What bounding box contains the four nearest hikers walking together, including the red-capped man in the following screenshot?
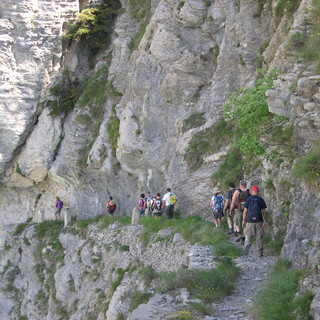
[210,181,268,257]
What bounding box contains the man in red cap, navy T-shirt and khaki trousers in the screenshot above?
[242,186,268,257]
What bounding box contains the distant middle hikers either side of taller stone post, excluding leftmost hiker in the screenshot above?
[106,188,177,219]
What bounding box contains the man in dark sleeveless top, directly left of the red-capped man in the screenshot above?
[230,180,250,244]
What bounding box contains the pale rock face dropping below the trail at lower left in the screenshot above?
[0,223,213,320]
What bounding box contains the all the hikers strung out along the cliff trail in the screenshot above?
[52,181,268,257]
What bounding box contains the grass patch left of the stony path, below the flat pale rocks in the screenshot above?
[155,258,239,302]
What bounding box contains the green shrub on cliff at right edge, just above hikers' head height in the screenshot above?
[293,142,320,186]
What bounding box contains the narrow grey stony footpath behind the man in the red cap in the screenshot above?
[210,236,277,320]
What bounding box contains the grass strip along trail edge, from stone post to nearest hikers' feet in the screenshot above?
[141,216,241,258]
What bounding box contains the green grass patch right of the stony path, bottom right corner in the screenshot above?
[254,259,312,320]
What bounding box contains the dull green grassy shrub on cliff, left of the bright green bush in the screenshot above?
[184,119,232,170]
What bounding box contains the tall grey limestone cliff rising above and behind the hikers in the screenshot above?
[0,0,320,318]
